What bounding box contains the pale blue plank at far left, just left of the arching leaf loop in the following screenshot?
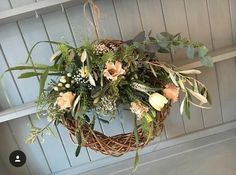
[0,23,38,102]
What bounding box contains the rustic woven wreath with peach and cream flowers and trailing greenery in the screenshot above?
[1,32,212,169]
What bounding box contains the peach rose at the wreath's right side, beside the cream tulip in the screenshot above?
[163,84,179,102]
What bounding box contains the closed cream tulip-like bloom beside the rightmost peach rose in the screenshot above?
[148,93,168,111]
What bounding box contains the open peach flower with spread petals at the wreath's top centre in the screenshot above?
[103,61,125,81]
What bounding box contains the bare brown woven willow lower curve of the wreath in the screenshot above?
[63,103,171,157]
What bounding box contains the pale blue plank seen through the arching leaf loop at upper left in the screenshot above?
[19,14,92,166]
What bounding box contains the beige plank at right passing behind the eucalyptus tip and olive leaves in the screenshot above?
[186,0,222,127]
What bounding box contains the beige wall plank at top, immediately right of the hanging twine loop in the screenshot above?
[114,0,143,40]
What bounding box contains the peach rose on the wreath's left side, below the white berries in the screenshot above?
[57,92,75,110]
